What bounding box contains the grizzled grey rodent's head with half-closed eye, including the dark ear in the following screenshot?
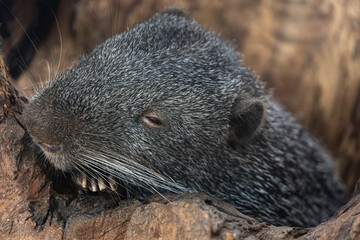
[24,10,265,195]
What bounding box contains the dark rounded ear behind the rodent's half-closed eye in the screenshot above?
[230,99,266,142]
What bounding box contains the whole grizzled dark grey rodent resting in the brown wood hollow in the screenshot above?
[24,9,346,227]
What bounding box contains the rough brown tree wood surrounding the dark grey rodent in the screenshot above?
[0,0,360,240]
